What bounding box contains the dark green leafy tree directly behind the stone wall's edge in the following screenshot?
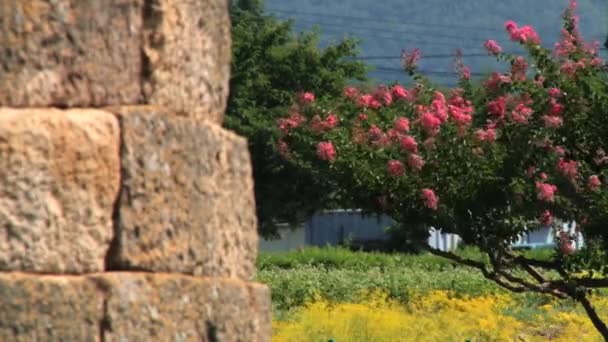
[225,0,366,235]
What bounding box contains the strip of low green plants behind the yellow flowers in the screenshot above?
[256,248,552,315]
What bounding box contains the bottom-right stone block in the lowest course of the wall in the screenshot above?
[99,273,271,342]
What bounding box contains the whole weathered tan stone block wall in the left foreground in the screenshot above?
[0,0,270,341]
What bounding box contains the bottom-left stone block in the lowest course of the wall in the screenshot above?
[0,273,104,342]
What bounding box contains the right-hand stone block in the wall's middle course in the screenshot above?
[108,106,257,279]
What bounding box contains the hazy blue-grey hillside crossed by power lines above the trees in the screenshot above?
[266,0,608,85]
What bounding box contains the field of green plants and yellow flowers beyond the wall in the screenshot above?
[256,247,608,342]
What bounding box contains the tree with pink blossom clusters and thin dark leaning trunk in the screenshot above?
[278,1,608,339]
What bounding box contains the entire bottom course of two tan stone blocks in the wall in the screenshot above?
[0,272,271,342]
